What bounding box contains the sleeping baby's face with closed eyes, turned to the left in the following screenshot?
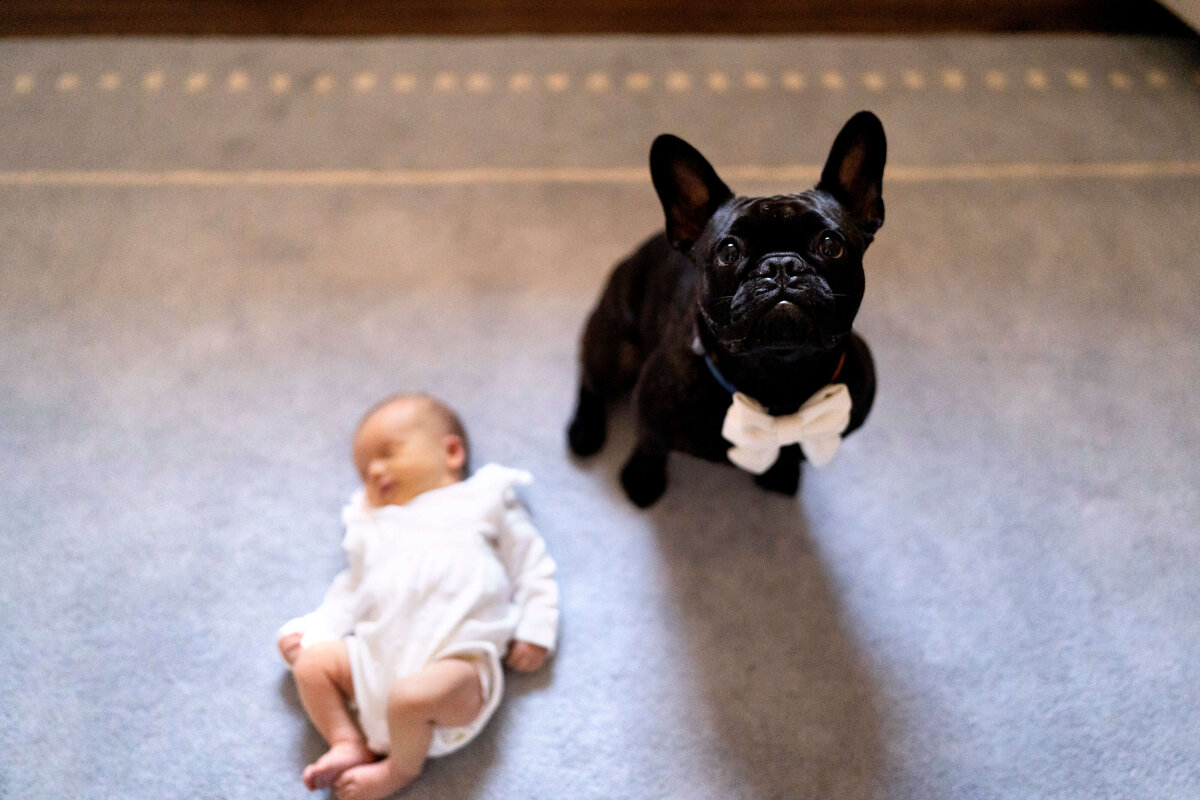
[354,399,464,506]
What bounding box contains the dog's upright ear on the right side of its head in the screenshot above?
[817,112,888,242]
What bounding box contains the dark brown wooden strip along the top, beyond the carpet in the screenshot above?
[0,0,1192,36]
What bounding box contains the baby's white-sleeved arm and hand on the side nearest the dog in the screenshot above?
[497,491,558,670]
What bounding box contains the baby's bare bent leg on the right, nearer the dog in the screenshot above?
[334,658,484,800]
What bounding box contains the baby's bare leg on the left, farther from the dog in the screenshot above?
[292,642,376,789]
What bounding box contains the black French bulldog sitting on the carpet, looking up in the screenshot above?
[568,112,887,507]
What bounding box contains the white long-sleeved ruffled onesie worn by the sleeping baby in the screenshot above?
[278,464,558,756]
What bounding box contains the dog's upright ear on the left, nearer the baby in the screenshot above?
[650,133,733,251]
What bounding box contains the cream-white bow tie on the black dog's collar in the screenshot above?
[721,384,851,475]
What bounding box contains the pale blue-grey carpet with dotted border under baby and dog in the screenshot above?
[0,36,1200,800]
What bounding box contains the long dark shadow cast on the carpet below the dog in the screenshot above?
[649,456,883,800]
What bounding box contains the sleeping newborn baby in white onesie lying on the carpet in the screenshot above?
[278,395,558,800]
